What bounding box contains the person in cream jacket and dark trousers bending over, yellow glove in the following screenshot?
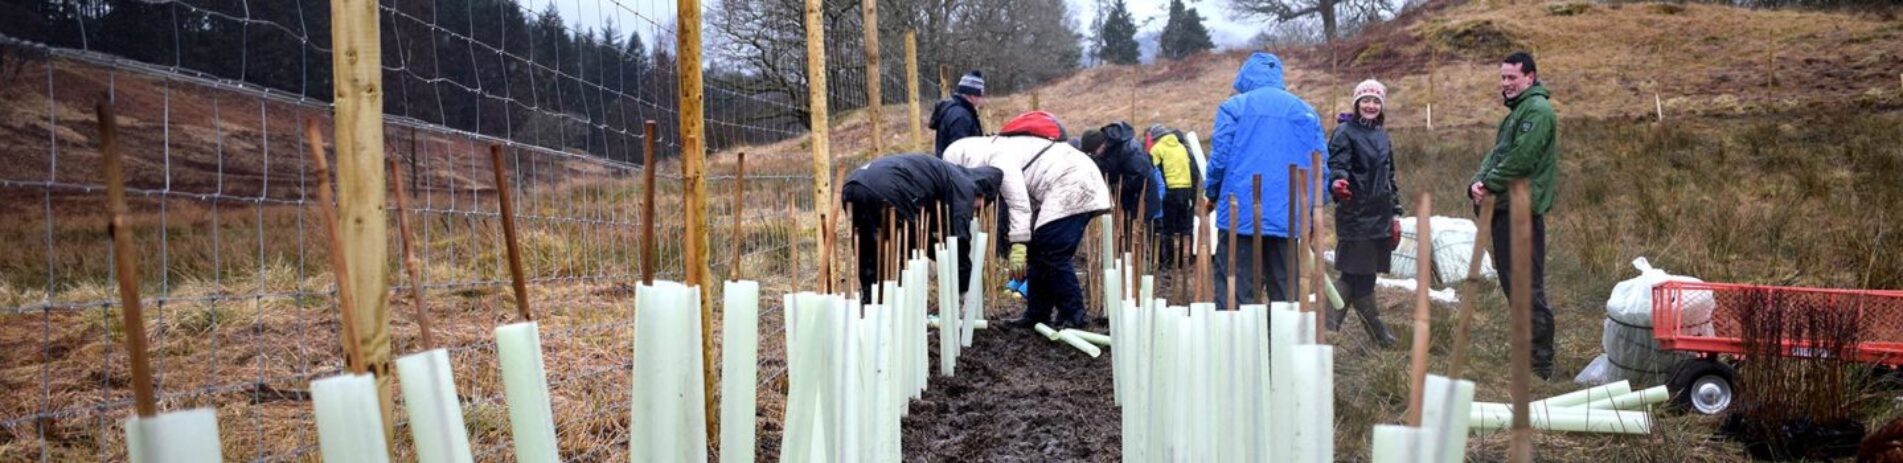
[944,111,1111,328]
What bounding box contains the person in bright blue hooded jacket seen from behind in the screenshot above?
[1203,51,1328,309]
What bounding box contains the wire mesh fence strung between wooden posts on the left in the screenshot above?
[0,0,924,461]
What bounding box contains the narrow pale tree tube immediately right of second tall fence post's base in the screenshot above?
[719,280,761,463]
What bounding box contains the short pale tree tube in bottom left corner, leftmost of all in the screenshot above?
[126,408,221,463]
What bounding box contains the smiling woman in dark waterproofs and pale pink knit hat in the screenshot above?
[1328,78,1401,347]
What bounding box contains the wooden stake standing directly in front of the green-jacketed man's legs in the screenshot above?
[1507,179,1534,463]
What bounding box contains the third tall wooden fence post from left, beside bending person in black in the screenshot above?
[807,0,834,290]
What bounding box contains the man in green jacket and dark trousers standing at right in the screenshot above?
[1467,51,1559,379]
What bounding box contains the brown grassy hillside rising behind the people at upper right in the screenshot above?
[716,0,1903,171]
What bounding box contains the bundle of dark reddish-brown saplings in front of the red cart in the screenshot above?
[1717,290,1874,459]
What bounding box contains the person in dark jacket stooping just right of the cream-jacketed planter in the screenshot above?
[1079,120,1163,242]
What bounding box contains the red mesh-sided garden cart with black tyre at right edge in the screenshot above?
[1652,282,1903,415]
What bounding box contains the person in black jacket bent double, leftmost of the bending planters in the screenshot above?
[839,154,1003,301]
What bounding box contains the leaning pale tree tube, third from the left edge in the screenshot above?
[396,349,476,463]
